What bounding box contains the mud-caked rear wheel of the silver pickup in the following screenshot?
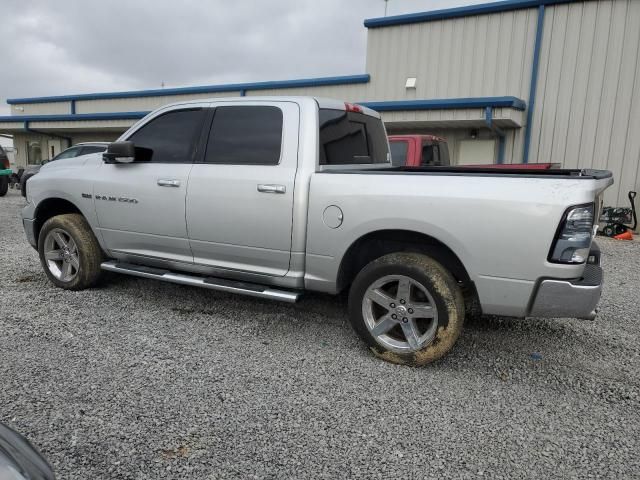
[349,253,465,366]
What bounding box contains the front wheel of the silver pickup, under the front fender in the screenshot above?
[38,213,103,290]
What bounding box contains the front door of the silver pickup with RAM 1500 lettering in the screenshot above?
[93,107,206,263]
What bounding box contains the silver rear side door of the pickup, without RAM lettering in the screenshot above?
[187,101,299,276]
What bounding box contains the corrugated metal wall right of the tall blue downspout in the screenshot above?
[530,0,640,205]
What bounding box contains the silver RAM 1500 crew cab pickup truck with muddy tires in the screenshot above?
[22,97,613,365]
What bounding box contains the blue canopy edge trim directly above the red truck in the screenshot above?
[358,97,527,112]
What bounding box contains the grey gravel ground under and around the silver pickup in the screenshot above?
[0,191,640,479]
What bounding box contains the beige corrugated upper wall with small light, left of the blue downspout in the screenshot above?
[367,9,537,100]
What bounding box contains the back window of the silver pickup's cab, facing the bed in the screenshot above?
[319,108,388,165]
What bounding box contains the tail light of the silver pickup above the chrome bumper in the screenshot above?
[549,203,595,263]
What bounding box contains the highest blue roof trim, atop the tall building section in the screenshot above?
[364,0,584,28]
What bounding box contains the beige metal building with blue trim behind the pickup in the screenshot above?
[0,0,640,205]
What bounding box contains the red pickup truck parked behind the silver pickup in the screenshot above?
[389,135,560,170]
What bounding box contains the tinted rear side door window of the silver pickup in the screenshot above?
[205,105,283,165]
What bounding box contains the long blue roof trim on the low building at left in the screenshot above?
[7,73,371,105]
